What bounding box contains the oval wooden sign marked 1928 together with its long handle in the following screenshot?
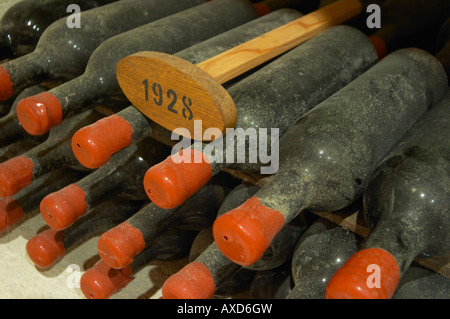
[117,0,362,141]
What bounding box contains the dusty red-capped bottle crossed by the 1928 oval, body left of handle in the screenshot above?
[72,9,301,167]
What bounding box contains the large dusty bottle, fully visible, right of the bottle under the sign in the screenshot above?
[213,49,447,265]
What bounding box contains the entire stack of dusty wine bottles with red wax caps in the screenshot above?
[0,0,450,299]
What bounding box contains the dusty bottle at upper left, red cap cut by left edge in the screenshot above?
[0,0,204,103]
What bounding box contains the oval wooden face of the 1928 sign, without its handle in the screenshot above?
[117,51,237,139]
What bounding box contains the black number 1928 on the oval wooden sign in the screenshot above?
[142,79,194,120]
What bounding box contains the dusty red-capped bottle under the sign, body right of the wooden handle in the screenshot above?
[144,26,377,208]
